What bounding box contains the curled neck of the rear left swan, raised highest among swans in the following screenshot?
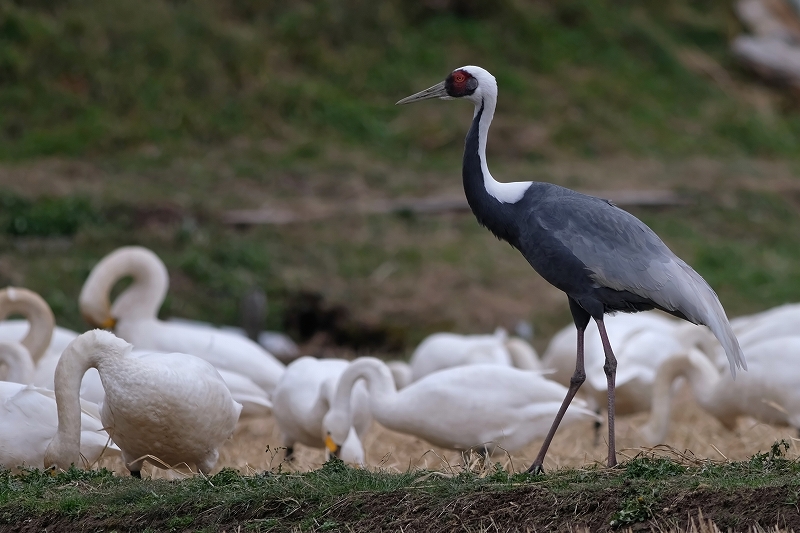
[80,249,169,320]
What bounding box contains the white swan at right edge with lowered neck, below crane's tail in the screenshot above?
[640,336,800,444]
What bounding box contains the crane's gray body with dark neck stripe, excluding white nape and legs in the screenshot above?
[463,102,744,373]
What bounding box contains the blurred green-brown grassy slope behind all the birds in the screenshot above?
[0,0,800,358]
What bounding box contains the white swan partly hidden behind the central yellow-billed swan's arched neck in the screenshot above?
[273,356,372,464]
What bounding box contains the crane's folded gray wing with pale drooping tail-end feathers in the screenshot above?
[537,193,747,375]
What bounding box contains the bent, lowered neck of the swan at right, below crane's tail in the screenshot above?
[648,350,720,442]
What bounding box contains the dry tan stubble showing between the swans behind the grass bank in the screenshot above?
[97,382,800,477]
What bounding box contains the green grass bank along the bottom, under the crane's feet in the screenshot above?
[0,448,800,531]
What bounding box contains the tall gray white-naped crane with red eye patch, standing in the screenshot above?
[397,66,747,473]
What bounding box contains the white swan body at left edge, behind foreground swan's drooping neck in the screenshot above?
[0,381,119,471]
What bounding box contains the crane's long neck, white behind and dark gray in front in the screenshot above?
[462,97,531,244]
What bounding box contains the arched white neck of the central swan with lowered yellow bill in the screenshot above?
[331,357,397,423]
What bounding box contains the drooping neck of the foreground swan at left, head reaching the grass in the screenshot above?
[44,337,102,469]
